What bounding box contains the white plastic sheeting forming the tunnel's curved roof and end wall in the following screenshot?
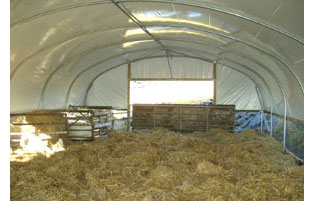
[11,0,304,120]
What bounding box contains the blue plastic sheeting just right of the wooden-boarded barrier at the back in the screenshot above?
[234,112,280,133]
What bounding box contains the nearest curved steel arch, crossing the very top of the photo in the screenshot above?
[10,0,304,44]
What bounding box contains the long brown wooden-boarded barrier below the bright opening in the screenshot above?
[132,104,235,131]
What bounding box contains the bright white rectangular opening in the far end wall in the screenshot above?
[130,80,214,105]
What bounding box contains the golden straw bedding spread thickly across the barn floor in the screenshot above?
[11,130,304,201]
